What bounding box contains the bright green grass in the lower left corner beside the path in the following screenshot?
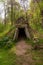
[0,49,16,65]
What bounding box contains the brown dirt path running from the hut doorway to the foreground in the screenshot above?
[12,40,34,65]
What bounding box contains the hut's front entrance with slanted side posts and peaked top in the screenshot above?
[14,17,30,39]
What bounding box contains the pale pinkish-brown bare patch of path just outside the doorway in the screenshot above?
[16,40,31,56]
